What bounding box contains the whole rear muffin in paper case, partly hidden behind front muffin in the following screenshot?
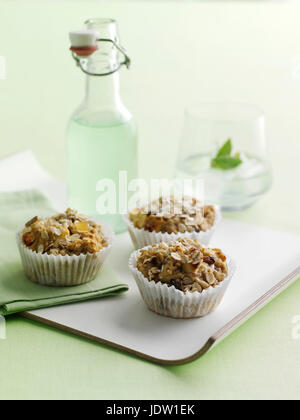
[124,197,221,249]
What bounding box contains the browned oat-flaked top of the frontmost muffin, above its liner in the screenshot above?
[136,239,228,293]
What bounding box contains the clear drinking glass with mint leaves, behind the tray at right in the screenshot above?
[176,103,272,211]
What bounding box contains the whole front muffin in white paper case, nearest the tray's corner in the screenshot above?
[129,238,235,318]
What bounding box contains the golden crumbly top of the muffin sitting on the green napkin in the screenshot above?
[22,209,108,256]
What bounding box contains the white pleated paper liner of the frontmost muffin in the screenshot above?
[129,247,236,318]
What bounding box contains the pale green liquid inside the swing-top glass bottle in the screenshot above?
[67,118,137,233]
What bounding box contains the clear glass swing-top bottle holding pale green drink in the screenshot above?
[67,19,137,233]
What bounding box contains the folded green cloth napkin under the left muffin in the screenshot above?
[0,191,128,315]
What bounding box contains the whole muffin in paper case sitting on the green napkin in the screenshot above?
[17,209,113,286]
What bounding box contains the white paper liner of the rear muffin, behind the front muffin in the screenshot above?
[123,206,222,249]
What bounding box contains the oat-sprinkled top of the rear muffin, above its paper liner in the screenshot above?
[129,197,216,234]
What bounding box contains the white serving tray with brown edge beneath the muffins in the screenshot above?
[24,220,300,365]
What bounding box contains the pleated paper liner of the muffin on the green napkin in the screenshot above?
[17,220,114,287]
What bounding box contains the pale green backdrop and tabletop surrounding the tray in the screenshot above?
[0,1,300,399]
